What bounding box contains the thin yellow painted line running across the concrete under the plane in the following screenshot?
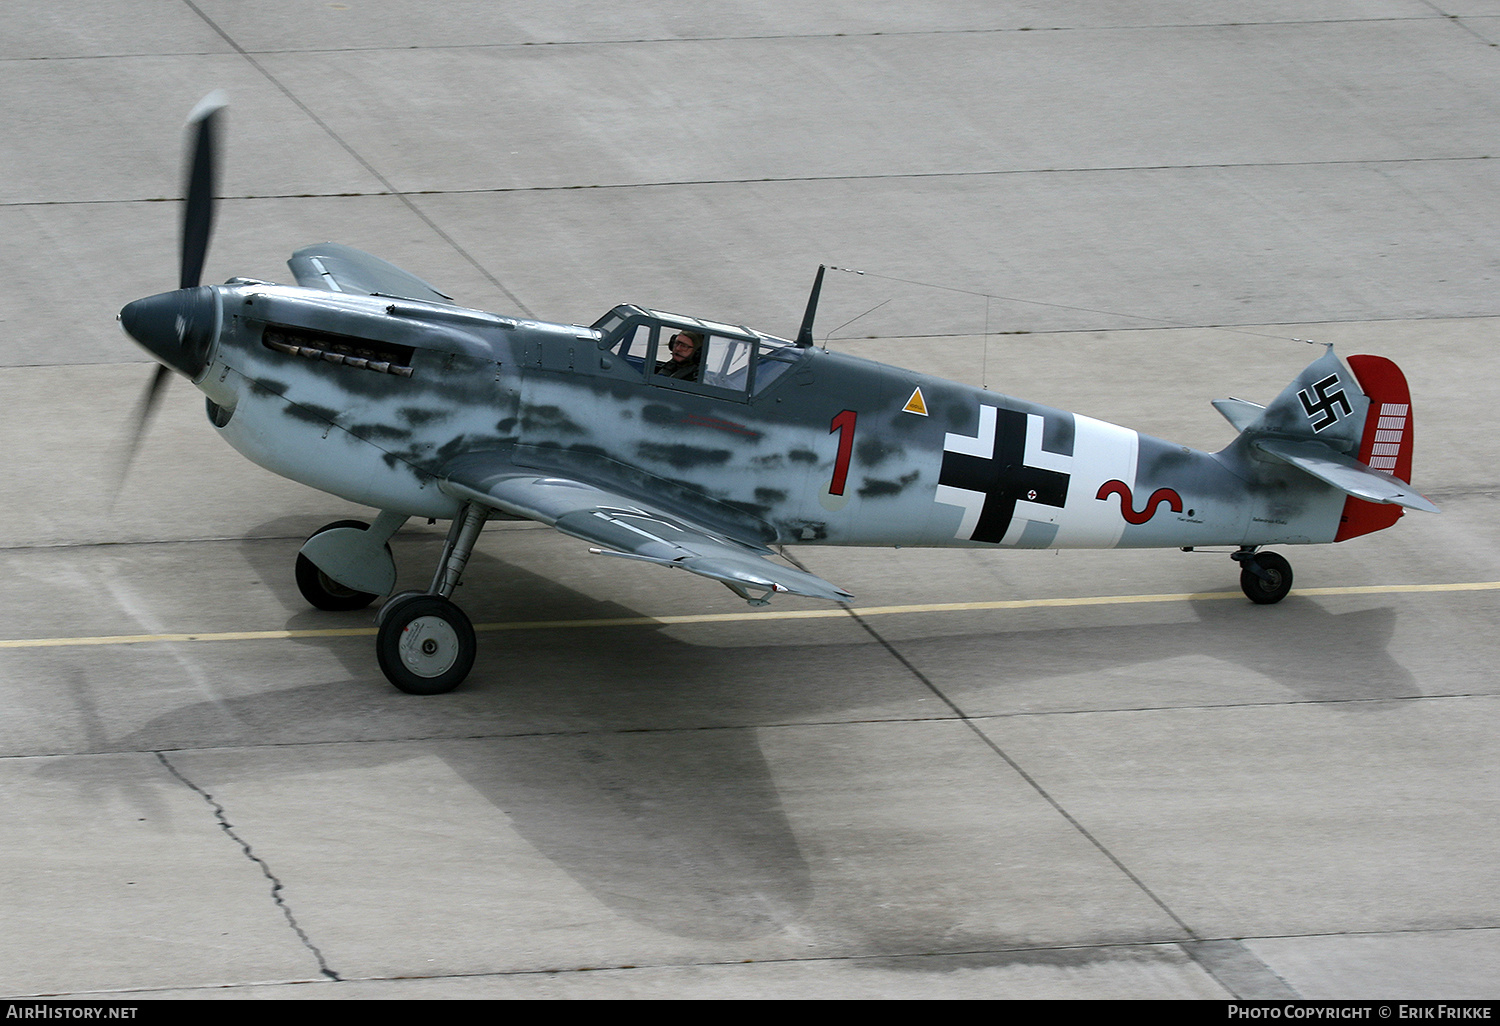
[0,581,1500,648]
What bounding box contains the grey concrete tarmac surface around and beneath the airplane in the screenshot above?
[0,0,1500,999]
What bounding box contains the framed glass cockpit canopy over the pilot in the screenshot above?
[593,303,806,402]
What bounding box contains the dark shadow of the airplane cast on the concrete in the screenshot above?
[43,525,1416,939]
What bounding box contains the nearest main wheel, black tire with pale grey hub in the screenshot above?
[375,596,479,695]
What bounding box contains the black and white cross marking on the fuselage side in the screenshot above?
[936,405,1070,545]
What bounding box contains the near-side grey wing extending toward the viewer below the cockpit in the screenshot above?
[440,453,854,605]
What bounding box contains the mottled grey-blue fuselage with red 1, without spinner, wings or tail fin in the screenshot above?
[172,282,1344,548]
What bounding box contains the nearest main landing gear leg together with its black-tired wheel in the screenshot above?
[375,503,489,695]
